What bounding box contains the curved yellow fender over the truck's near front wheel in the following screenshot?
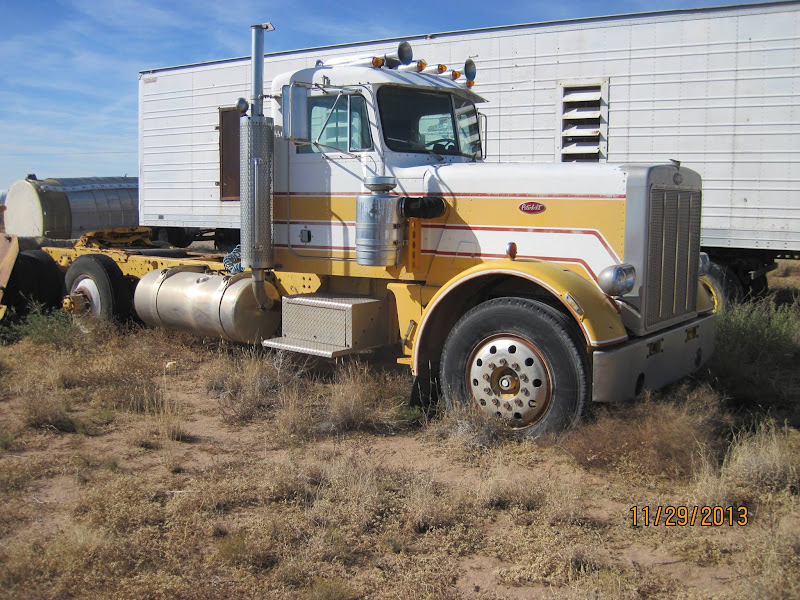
[413,259,628,373]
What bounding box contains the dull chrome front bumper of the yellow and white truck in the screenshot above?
[592,314,715,402]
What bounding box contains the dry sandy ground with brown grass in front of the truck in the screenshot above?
[0,264,800,600]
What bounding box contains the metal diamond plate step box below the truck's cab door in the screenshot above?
[262,294,392,358]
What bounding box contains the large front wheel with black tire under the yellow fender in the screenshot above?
[440,298,589,437]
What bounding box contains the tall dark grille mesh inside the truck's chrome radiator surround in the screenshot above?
[645,187,702,329]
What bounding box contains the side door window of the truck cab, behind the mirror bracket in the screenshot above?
[297,94,372,154]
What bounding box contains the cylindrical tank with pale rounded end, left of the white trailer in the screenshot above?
[4,177,139,239]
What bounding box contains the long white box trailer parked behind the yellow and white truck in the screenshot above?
[139,1,800,295]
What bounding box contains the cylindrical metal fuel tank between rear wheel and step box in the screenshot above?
[133,267,280,344]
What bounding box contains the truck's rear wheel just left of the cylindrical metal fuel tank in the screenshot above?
[65,254,131,320]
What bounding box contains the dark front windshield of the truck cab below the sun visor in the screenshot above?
[378,86,481,158]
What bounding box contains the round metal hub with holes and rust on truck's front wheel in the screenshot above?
[466,334,552,428]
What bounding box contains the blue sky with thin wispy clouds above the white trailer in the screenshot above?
[0,0,764,190]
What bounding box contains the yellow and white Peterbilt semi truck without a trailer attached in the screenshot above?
[0,23,714,436]
